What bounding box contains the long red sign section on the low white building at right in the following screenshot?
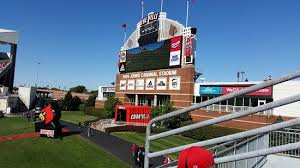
[222,86,272,96]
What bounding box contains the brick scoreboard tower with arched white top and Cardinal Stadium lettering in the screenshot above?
[116,12,197,108]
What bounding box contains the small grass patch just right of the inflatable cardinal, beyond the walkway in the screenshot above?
[61,111,97,124]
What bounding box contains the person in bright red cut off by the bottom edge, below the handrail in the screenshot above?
[177,146,216,168]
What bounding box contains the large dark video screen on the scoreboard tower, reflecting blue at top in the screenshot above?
[123,40,171,72]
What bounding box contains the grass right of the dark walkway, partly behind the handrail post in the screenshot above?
[112,132,196,159]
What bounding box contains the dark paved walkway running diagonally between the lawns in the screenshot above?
[61,121,164,167]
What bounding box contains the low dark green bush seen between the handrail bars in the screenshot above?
[181,121,242,141]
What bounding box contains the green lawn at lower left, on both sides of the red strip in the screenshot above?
[0,118,129,168]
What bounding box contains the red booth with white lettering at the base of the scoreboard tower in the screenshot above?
[115,105,151,124]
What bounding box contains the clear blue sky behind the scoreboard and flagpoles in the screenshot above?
[0,0,300,89]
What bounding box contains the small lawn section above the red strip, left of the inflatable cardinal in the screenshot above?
[0,117,34,136]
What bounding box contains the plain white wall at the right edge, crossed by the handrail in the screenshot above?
[273,81,300,117]
